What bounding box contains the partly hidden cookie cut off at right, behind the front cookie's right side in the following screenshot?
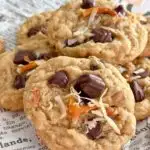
[120,57,150,120]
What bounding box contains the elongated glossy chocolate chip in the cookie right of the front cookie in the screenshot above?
[130,81,145,102]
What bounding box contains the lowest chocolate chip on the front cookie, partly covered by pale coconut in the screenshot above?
[86,121,102,140]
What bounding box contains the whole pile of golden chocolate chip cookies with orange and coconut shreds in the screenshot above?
[0,0,150,150]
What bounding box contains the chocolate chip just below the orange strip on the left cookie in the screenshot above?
[14,75,27,89]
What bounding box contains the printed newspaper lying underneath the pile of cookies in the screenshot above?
[0,0,150,150]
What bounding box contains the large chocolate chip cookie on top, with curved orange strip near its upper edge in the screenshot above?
[48,0,147,64]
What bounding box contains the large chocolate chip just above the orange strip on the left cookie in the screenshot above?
[14,51,36,65]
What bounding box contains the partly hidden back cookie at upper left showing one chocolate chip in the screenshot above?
[17,11,52,51]
